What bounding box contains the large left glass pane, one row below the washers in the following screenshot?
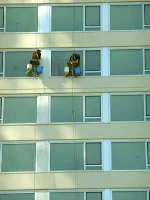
[4,97,37,123]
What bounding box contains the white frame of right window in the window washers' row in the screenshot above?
[109,46,150,76]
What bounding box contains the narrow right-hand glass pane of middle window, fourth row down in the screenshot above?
[86,142,101,165]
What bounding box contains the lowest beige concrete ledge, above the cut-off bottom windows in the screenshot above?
[0,171,150,191]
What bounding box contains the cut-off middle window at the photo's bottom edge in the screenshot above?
[50,192,102,200]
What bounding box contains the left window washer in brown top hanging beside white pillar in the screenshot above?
[26,50,41,77]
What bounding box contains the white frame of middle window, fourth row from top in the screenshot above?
[48,140,104,172]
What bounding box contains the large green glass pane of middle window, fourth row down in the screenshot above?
[50,143,84,171]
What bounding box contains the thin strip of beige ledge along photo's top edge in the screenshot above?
[0,0,149,5]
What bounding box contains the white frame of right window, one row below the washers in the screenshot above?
[109,92,150,123]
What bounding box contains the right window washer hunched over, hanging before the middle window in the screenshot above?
[64,54,80,77]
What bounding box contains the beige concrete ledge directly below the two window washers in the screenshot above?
[0,76,150,95]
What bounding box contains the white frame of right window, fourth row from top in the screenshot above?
[110,139,150,171]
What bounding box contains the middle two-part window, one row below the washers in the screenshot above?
[51,96,101,123]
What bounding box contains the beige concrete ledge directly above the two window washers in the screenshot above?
[0,30,150,49]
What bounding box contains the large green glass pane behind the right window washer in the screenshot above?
[51,51,83,76]
